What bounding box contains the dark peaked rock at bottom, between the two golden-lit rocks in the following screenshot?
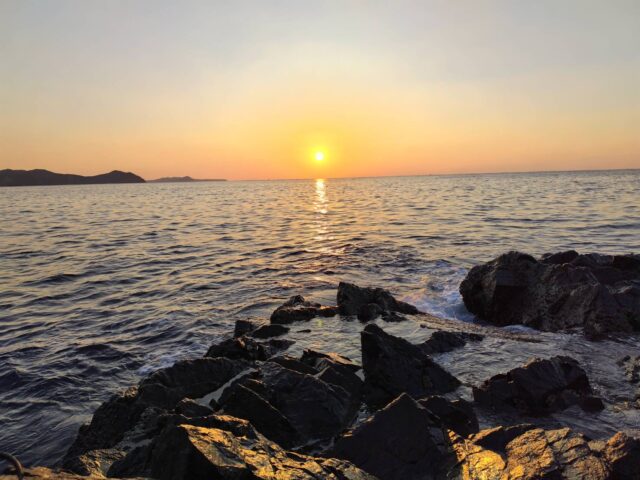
[331,394,448,480]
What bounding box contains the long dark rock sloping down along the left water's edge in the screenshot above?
[62,358,249,473]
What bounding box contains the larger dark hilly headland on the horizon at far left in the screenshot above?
[0,169,144,187]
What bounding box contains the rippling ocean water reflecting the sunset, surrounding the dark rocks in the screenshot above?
[0,171,640,465]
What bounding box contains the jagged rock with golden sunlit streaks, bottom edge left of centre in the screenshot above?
[134,417,375,480]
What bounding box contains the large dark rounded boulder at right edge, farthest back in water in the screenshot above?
[460,251,640,338]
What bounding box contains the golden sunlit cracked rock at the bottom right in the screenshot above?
[450,428,618,480]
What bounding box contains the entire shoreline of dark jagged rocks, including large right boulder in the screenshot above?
[5,252,640,480]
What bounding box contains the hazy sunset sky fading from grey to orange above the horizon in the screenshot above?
[0,0,640,179]
